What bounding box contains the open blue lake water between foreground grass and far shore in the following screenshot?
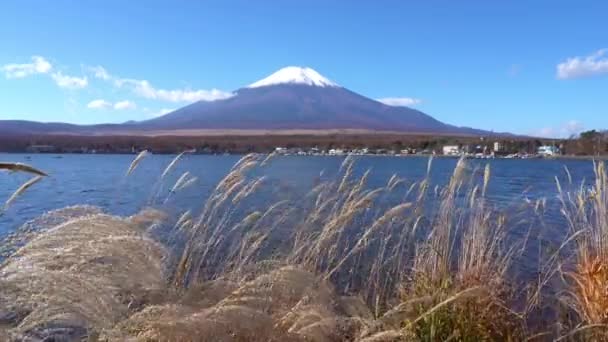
[0,154,593,252]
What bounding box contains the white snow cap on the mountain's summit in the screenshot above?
[247,66,339,88]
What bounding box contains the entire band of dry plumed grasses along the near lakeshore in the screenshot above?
[0,152,608,342]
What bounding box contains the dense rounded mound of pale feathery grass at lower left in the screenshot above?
[0,211,165,340]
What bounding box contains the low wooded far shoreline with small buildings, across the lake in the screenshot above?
[0,131,608,158]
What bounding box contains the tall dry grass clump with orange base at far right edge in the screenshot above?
[557,162,608,340]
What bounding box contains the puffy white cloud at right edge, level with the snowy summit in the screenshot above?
[557,49,608,80]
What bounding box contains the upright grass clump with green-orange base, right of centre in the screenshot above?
[401,159,528,341]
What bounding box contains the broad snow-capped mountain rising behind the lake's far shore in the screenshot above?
[0,66,489,135]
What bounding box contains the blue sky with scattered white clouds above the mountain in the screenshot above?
[0,0,608,136]
